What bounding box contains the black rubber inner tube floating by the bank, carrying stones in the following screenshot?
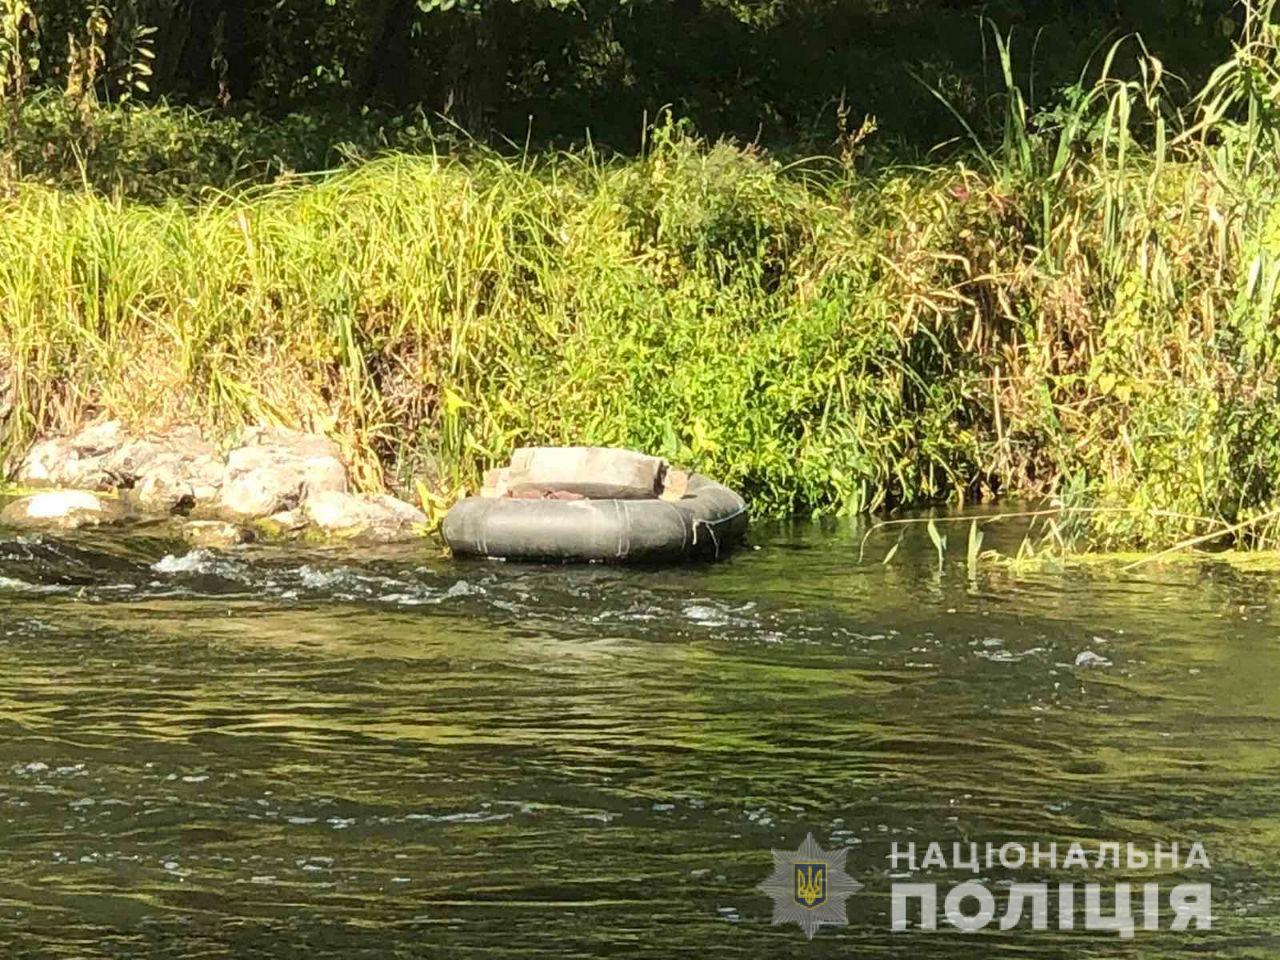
[443,474,746,563]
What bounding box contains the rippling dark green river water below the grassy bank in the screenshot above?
[0,524,1280,960]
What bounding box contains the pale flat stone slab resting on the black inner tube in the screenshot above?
[507,447,667,499]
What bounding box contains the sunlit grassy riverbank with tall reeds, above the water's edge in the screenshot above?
[0,12,1280,548]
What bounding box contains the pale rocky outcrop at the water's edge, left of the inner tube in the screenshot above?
[4,420,426,545]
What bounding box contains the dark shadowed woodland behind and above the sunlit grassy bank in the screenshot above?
[9,0,1238,151]
